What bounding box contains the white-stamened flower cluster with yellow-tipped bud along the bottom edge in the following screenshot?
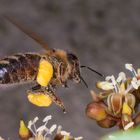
[19,115,83,140]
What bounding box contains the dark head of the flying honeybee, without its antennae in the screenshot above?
[67,53,81,83]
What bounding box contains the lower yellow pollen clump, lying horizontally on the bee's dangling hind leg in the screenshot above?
[28,92,52,107]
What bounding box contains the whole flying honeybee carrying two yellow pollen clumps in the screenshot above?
[0,16,102,112]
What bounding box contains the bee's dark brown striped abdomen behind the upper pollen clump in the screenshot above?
[0,53,41,84]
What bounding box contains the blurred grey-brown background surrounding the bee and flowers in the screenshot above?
[0,0,140,140]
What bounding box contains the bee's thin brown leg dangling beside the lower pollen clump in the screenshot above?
[45,85,66,113]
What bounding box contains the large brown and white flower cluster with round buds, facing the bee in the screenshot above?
[86,64,140,130]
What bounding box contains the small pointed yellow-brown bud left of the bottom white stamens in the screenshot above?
[19,120,30,137]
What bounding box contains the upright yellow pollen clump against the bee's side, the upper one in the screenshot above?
[37,60,53,87]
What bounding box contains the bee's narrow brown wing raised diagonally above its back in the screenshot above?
[4,15,50,50]
